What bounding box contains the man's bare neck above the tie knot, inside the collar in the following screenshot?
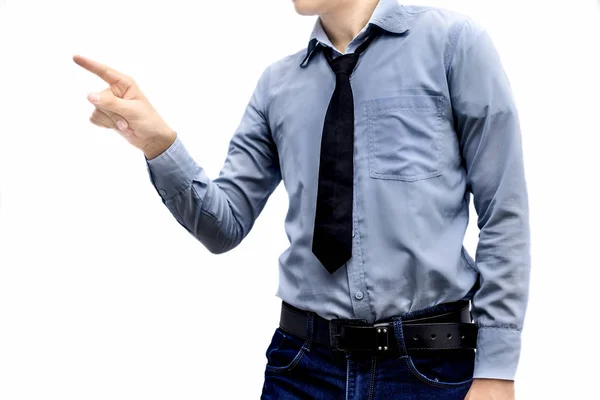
[319,0,379,54]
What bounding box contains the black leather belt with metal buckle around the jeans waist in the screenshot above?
[279,300,477,352]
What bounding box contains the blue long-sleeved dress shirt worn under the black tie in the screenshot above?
[146,0,530,379]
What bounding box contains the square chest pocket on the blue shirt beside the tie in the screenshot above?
[366,94,443,181]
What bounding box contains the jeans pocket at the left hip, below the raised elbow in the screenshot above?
[266,328,308,373]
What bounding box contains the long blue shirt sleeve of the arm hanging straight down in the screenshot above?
[448,20,530,380]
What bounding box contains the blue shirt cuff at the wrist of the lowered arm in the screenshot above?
[473,327,521,380]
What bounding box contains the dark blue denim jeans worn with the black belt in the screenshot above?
[261,303,475,400]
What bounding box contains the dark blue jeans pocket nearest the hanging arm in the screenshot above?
[404,349,475,387]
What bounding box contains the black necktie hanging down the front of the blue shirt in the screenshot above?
[312,29,379,274]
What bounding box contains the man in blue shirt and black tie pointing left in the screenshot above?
[74,0,530,400]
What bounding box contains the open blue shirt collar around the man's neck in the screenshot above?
[300,0,408,67]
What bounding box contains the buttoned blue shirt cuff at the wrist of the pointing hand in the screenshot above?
[144,136,201,201]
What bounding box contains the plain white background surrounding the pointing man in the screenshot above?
[0,0,600,400]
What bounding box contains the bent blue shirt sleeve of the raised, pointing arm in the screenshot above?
[146,68,281,254]
